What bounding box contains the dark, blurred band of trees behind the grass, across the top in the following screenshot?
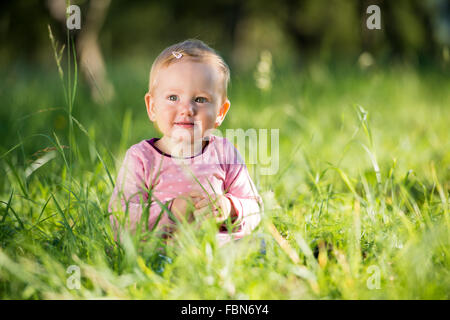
[0,0,450,73]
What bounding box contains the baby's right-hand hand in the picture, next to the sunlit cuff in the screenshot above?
[189,191,234,223]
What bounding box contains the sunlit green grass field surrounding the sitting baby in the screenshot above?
[0,43,450,299]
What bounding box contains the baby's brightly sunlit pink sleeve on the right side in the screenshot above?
[224,145,263,237]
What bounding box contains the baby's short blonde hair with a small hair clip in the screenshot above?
[148,39,230,99]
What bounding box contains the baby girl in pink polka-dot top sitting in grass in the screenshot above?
[109,40,263,244]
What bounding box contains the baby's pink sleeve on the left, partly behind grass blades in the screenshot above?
[108,148,173,238]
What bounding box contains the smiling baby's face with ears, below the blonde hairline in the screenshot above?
[145,57,230,143]
